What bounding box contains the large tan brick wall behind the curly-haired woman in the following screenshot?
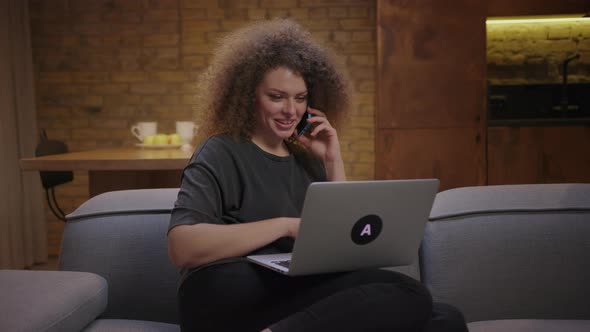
[29,0,376,255]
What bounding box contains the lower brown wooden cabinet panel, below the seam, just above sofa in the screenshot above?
[376,128,486,190]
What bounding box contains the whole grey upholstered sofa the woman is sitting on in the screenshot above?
[0,184,590,332]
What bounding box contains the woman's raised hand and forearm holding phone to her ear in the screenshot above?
[296,107,346,181]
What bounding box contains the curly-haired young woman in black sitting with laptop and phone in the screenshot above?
[168,20,467,332]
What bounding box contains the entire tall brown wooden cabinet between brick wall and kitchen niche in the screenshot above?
[375,0,487,190]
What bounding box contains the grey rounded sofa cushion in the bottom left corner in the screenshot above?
[0,270,108,331]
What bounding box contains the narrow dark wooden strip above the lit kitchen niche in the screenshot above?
[487,0,590,16]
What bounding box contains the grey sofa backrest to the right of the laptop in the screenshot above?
[420,184,590,321]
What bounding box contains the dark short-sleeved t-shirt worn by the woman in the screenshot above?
[168,135,326,274]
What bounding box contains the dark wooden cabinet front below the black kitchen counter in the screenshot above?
[488,126,590,185]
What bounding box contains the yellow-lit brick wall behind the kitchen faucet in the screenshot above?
[487,22,590,84]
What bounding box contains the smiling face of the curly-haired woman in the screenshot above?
[253,67,307,143]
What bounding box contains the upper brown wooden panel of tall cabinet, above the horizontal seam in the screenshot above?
[377,0,486,128]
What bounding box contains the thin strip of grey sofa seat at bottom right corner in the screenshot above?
[468,319,590,332]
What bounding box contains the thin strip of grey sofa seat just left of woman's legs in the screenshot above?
[84,319,180,332]
